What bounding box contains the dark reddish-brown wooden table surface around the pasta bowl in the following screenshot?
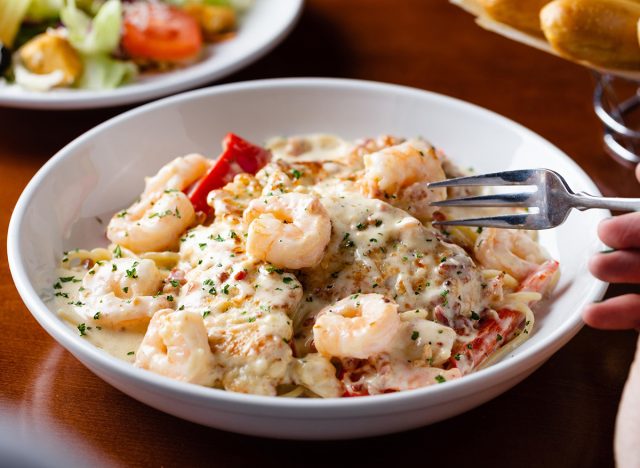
[0,0,640,467]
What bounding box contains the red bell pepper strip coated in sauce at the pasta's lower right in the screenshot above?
[449,309,524,374]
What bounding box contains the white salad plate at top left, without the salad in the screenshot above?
[0,0,304,109]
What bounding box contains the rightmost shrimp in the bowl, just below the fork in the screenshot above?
[474,228,549,281]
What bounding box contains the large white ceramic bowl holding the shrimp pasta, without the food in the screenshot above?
[8,79,608,439]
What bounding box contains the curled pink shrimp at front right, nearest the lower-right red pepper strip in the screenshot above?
[313,294,401,359]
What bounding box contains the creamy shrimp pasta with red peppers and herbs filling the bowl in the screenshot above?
[53,134,558,398]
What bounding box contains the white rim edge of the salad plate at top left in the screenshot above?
[0,0,304,110]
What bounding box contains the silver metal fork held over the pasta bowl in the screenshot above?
[429,169,640,229]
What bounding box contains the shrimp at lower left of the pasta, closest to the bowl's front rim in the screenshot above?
[134,309,217,386]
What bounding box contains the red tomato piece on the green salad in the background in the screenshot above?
[122,2,202,62]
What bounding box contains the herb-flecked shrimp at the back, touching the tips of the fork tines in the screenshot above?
[360,140,447,221]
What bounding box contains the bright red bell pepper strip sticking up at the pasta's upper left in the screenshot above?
[189,133,271,213]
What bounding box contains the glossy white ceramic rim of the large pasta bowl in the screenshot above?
[7,78,608,419]
